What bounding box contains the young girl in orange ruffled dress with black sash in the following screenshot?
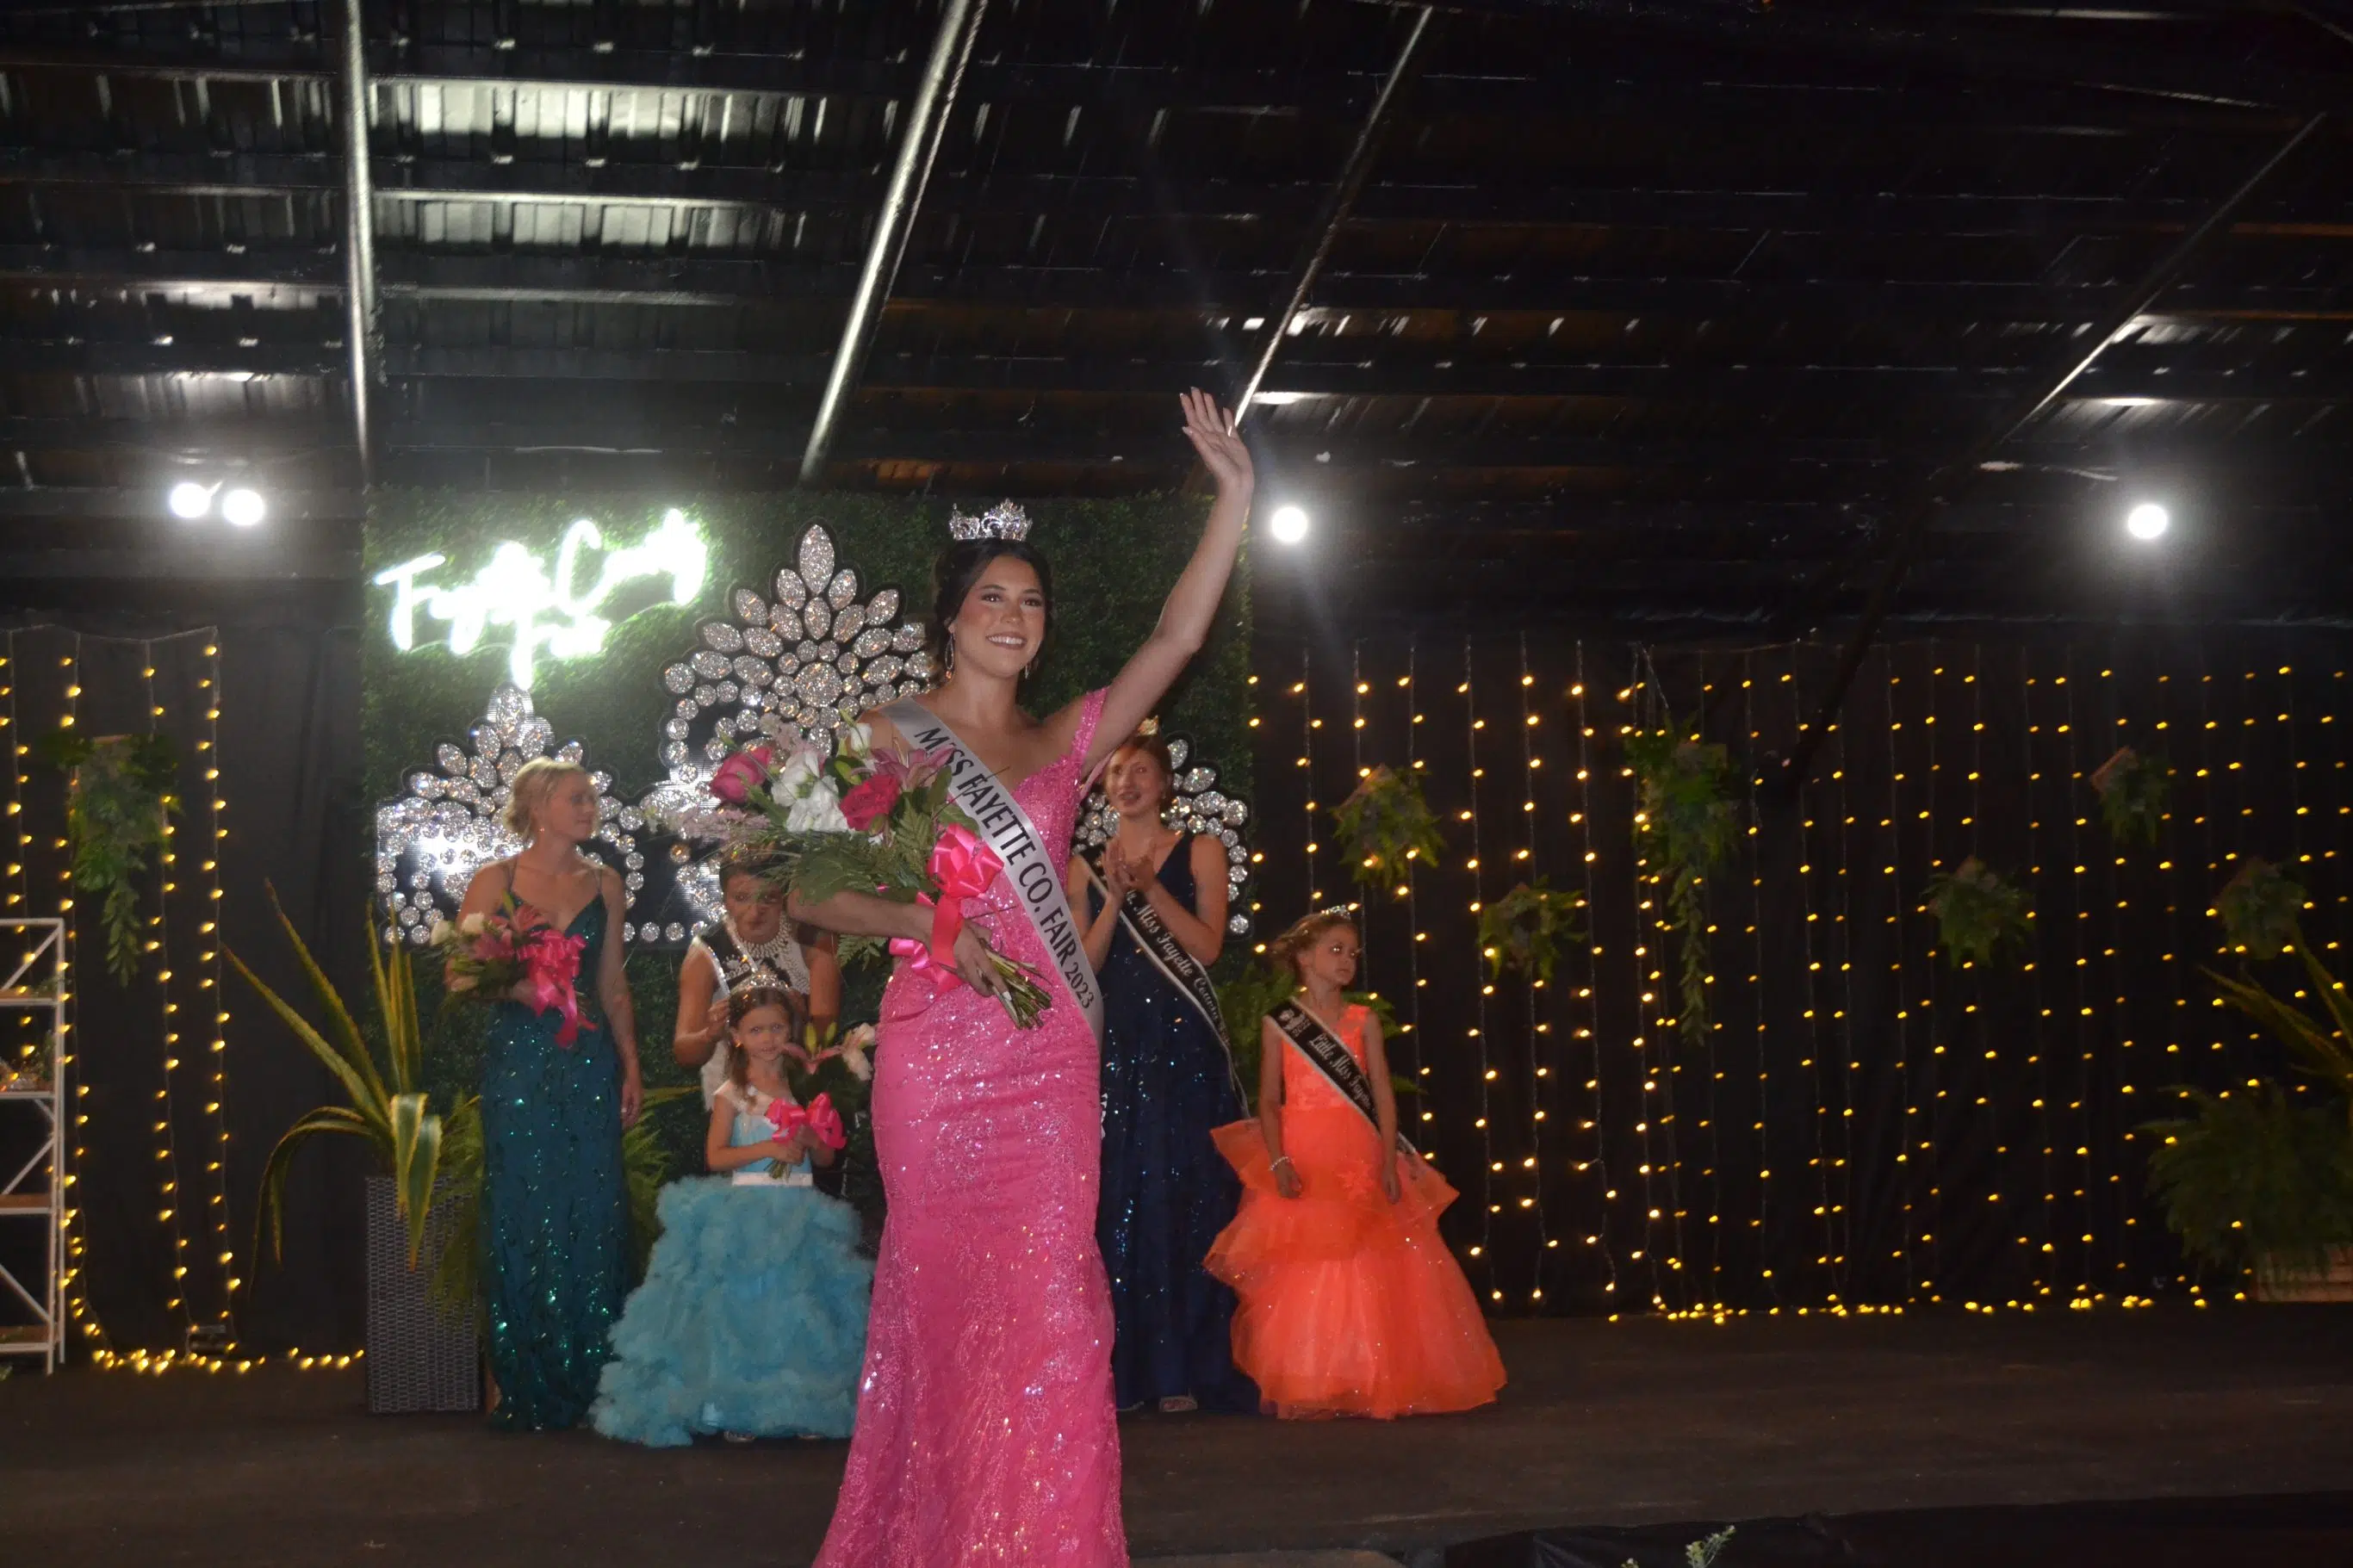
[1208,910,1504,1417]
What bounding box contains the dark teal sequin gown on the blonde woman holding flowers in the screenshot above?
[482,898,628,1432]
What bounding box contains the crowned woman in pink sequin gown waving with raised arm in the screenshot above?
[795,390,1251,1568]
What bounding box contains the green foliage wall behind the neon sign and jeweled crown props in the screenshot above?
[363,492,1251,1171]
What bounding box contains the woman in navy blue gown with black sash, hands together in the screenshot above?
[1071,734,1259,1410]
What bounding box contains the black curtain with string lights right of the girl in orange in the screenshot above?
[1254,630,2353,1314]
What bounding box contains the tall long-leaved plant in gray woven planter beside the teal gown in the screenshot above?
[228,889,482,1416]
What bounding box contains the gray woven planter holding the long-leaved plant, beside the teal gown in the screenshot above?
[367,1175,482,1416]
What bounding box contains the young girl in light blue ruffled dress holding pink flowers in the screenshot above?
[591,982,873,1448]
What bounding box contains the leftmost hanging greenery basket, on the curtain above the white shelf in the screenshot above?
[33,728,179,985]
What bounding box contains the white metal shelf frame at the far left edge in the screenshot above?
[0,917,71,1371]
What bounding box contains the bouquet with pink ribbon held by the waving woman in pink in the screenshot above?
[692,724,1052,1030]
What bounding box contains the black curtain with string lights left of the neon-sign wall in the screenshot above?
[0,595,369,1354]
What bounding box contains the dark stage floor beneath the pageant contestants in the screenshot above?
[0,1307,2353,1568]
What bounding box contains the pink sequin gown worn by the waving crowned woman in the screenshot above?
[816,691,1127,1568]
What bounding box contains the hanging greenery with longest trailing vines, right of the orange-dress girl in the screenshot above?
[1626,722,1741,1044]
